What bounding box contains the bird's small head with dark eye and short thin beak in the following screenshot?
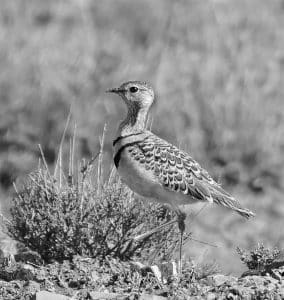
[107,81,154,110]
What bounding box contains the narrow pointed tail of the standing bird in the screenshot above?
[211,187,255,219]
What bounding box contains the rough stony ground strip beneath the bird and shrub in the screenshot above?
[0,252,284,300]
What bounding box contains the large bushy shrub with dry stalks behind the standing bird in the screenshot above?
[1,144,179,262]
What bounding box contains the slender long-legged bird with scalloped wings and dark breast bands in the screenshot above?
[107,81,254,272]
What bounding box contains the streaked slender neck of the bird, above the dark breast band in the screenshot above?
[118,104,149,136]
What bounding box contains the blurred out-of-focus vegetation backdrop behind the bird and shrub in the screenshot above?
[0,0,284,272]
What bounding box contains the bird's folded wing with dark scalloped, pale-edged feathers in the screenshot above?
[128,134,253,217]
